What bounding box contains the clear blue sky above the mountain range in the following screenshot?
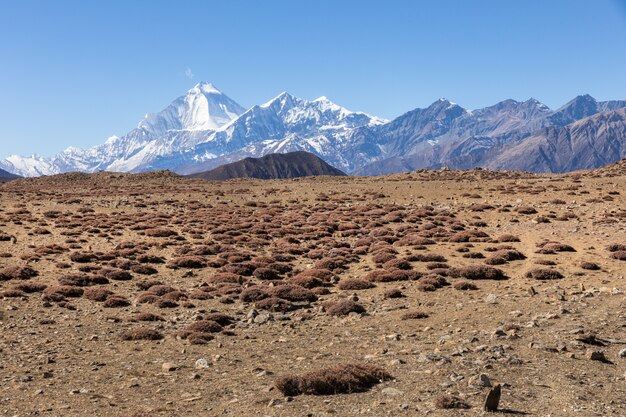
[0,0,626,156]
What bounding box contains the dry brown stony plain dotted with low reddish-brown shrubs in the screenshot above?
[0,161,626,417]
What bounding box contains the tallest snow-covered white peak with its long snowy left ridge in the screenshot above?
[0,82,245,176]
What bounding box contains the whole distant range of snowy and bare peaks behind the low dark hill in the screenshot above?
[0,82,626,176]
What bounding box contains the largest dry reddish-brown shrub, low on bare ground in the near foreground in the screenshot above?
[276,362,392,396]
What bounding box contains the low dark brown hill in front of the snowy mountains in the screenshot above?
[191,152,346,180]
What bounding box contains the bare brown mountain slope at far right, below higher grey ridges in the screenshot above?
[482,109,626,172]
